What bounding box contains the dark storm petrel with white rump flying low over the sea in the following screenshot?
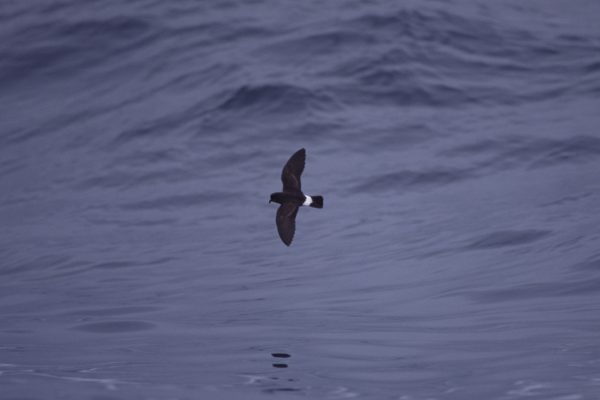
[269,149,323,246]
